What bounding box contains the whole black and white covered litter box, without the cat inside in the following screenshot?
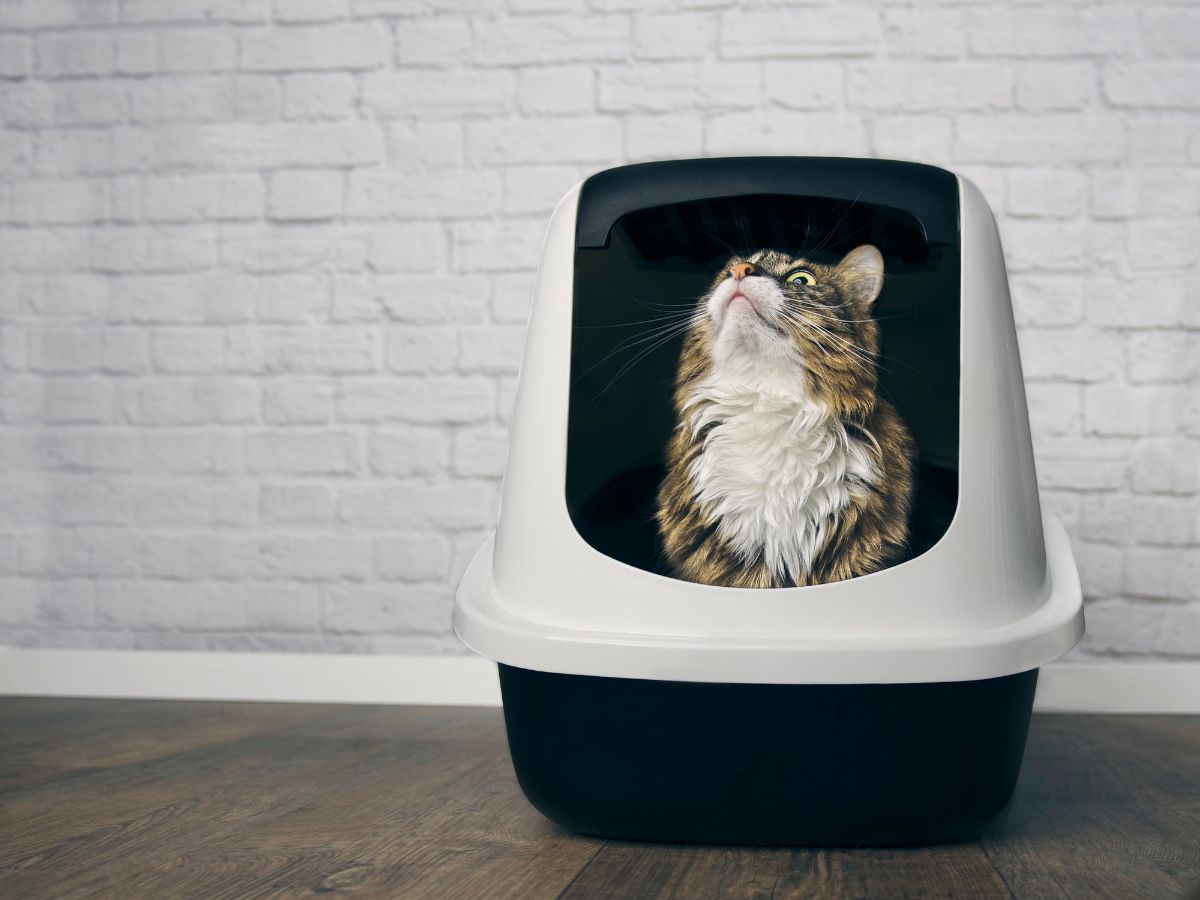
[454,157,1084,845]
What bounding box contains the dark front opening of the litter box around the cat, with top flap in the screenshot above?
[565,160,960,585]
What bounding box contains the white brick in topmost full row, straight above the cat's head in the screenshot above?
[718,7,881,59]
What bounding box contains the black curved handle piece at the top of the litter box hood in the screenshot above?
[575,156,959,247]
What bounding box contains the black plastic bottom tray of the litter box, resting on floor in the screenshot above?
[500,665,1037,846]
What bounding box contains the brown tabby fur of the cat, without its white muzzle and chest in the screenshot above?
[656,251,913,588]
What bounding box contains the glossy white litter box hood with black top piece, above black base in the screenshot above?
[454,157,1084,684]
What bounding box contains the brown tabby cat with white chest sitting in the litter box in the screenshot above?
[655,245,914,588]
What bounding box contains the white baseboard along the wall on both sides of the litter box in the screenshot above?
[0,647,1200,714]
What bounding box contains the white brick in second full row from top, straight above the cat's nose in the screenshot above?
[598,62,762,113]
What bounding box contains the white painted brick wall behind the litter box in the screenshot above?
[0,0,1200,658]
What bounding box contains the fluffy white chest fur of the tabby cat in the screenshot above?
[686,384,877,578]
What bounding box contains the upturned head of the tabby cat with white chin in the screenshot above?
[701,244,883,412]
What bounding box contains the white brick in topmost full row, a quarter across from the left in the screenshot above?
[239,23,391,72]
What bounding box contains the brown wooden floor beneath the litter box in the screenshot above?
[0,700,1200,900]
